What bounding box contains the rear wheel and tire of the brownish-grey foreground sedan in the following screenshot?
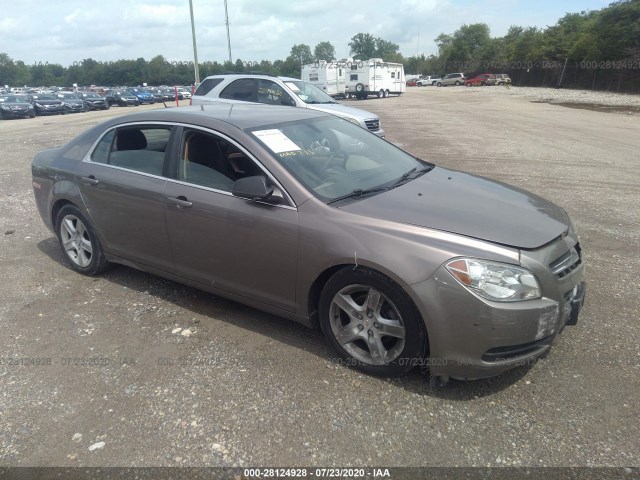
[56,205,109,276]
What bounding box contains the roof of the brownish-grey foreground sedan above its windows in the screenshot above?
[104,101,333,130]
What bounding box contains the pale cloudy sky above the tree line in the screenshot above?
[0,0,612,66]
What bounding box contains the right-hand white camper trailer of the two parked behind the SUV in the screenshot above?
[345,58,407,98]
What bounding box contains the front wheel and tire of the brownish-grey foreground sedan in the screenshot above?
[319,267,427,376]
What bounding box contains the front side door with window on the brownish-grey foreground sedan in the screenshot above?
[165,129,298,311]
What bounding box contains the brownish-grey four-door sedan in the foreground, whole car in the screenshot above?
[32,102,585,379]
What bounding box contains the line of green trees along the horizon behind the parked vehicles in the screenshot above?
[0,0,640,91]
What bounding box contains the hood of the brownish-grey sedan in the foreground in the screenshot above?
[341,167,569,249]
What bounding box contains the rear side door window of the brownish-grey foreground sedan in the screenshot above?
[91,126,171,176]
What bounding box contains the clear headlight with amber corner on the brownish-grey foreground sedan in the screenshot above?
[445,258,541,302]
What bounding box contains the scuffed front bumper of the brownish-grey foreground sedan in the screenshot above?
[409,244,586,380]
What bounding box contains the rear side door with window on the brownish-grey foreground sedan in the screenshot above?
[77,125,173,271]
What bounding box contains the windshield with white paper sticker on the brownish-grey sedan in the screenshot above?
[251,117,433,203]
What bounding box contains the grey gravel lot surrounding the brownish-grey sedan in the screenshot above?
[0,87,640,467]
